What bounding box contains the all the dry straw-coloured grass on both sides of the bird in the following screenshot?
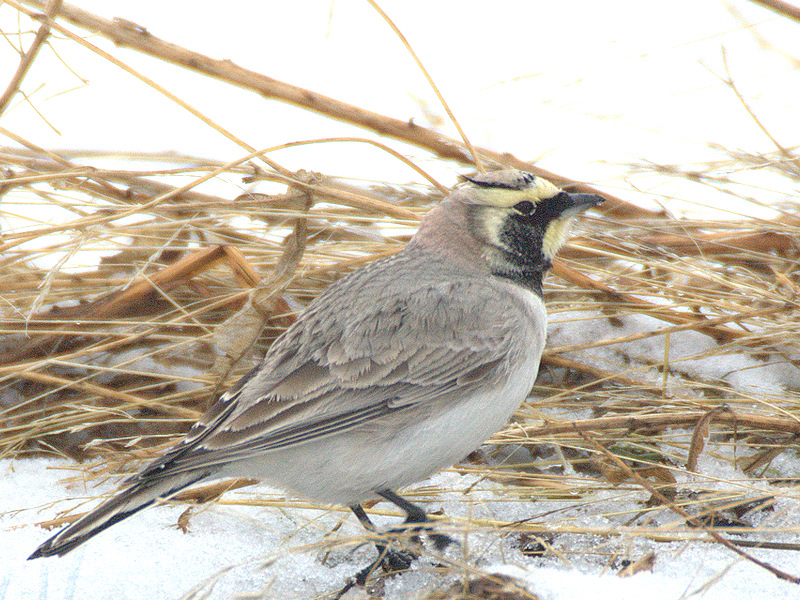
[0,0,800,592]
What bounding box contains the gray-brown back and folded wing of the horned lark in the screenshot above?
[138,272,543,473]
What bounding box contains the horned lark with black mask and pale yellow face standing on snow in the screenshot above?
[29,169,603,584]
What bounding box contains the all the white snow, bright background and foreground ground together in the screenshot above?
[0,0,800,600]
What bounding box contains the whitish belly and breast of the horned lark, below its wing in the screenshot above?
[226,286,545,505]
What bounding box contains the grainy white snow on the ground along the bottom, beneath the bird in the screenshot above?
[0,460,800,600]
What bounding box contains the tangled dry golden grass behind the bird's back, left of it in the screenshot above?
[0,150,432,456]
